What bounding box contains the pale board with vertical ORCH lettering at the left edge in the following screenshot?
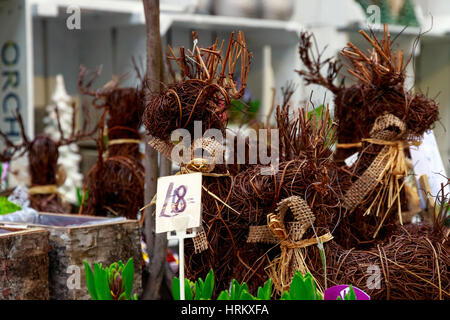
[0,0,34,145]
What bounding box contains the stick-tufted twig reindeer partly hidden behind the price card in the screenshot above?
[143,32,252,291]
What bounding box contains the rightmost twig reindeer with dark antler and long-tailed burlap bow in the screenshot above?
[298,25,438,247]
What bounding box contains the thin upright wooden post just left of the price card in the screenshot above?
[143,0,167,299]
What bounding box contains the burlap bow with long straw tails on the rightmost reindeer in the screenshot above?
[340,114,418,238]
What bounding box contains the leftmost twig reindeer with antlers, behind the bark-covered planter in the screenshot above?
[0,104,93,213]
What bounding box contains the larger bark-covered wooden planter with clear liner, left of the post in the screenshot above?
[0,213,142,300]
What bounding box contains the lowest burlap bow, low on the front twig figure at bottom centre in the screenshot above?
[247,196,333,293]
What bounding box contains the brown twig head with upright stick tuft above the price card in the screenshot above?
[143,32,251,141]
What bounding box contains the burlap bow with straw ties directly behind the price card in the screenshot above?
[141,137,234,253]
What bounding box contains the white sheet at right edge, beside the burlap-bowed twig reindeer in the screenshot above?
[410,131,450,208]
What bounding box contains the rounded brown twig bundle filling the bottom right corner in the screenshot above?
[307,224,450,300]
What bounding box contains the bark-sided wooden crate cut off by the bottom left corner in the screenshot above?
[0,227,49,300]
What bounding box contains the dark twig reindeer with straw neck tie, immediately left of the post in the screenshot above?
[79,67,144,219]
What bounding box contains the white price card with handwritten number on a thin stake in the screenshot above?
[155,173,202,233]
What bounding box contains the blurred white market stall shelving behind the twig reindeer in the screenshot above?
[0,0,450,201]
